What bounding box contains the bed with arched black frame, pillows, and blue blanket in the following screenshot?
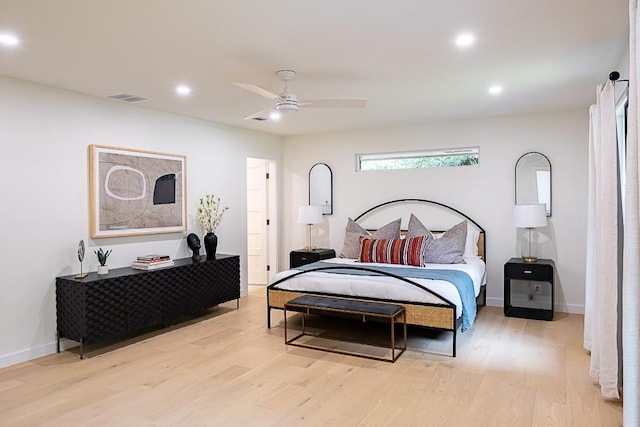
[267,199,486,357]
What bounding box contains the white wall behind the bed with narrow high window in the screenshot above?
[280,108,588,313]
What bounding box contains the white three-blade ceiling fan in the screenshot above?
[235,70,367,120]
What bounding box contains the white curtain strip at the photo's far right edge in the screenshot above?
[622,0,640,426]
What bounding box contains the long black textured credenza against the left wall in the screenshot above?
[56,254,240,358]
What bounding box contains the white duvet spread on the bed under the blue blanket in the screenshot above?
[271,257,486,318]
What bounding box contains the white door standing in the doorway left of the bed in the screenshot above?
[247,158,269,285]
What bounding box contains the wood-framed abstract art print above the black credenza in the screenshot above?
[89,145,187,238]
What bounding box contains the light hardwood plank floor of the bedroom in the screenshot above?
[0,288,622,427]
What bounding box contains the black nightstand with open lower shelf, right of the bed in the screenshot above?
[504,258,555,320]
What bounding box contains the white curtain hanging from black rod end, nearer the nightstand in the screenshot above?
[584,81,620,398]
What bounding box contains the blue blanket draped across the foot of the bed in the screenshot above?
[295,261,476,332]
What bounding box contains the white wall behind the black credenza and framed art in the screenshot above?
[0,78,282,366]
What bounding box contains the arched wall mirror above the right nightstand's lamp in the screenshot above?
[516,152,551,216]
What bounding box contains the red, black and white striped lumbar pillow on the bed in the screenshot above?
[358,236,431,267]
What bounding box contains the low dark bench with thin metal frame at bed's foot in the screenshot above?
[284,295,407,362]
